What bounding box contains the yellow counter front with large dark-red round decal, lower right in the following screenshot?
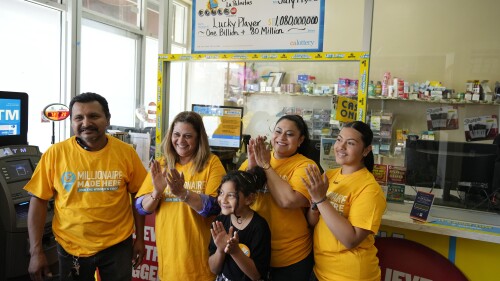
[376,196,500,281]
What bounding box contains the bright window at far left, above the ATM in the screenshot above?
[0,0,64,151]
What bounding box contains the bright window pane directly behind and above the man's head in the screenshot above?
[80,19,140,127]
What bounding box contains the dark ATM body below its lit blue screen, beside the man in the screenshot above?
[0,145,58,281]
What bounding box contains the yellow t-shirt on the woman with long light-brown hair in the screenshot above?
[137,155,226,281]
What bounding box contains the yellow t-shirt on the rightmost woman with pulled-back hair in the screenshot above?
[314,168,386,281]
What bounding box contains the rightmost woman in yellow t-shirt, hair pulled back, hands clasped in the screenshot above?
[303,121,386,281]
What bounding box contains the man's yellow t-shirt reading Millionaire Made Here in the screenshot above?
[24,136,147,257]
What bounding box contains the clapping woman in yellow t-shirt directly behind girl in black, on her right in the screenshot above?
[240,115,317,281]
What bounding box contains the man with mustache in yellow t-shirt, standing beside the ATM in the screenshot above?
[24,93,147,281]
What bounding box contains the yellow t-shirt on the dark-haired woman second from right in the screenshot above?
[240,153,316,267]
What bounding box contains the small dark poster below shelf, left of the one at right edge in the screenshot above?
[427,106,458,131]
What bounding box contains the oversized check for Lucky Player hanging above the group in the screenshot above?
[192,0,325,53]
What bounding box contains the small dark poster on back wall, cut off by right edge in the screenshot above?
[464,115,498,141]
